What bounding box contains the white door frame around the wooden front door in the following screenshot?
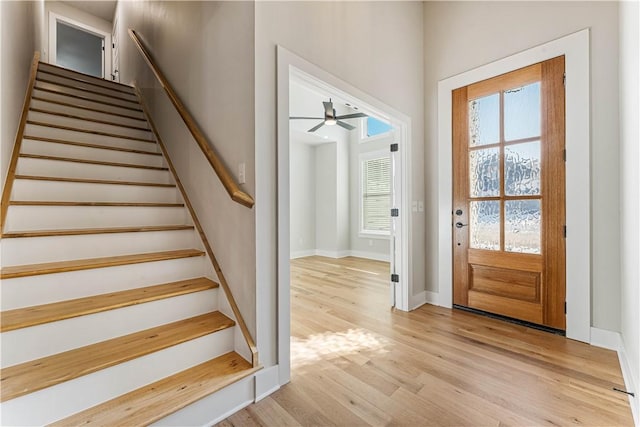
[437,28,591,342]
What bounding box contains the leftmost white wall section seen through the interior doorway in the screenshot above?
[289,137,316,257]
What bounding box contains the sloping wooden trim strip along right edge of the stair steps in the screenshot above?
[134,84,258,368]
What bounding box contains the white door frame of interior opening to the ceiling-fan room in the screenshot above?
[274,45,412,385]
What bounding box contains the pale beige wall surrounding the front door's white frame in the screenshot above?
[424,1,620,331]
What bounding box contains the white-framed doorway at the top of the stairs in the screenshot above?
[49,12,112,79]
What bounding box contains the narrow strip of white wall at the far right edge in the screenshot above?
[619,1,640,424]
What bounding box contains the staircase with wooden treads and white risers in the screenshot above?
[0,59,257,425]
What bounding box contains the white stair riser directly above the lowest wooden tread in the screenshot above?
[2,328,233,425]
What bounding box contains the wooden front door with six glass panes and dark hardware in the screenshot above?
[453,56,565,330]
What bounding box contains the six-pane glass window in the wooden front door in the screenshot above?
[468,82,542,255]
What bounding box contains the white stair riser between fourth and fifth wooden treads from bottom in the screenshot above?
[2,230,199,267]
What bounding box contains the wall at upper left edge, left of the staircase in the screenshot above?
[0,1,35,188]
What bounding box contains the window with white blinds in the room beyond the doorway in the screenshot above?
[361,155,391,234]
